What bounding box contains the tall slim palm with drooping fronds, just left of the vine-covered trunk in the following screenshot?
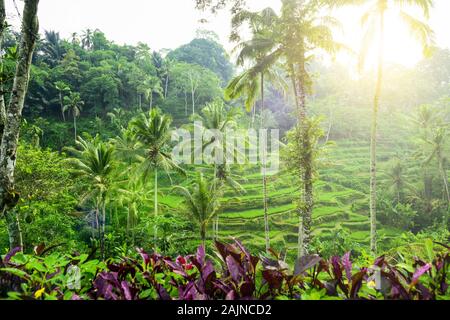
[225,8,281,251]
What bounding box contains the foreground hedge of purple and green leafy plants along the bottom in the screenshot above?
[0,240,450,300]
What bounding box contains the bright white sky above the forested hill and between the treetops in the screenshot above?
[6,0,450,65]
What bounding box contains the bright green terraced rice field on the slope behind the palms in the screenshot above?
[161,142,399,255]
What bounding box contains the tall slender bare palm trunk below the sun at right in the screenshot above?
[370,13,384,254]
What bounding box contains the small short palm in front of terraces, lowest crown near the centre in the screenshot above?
[174,173,220,246]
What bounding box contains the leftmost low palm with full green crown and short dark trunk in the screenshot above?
[67,136,115,255]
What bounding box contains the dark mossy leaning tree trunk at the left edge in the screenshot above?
[0,0,39,251]
